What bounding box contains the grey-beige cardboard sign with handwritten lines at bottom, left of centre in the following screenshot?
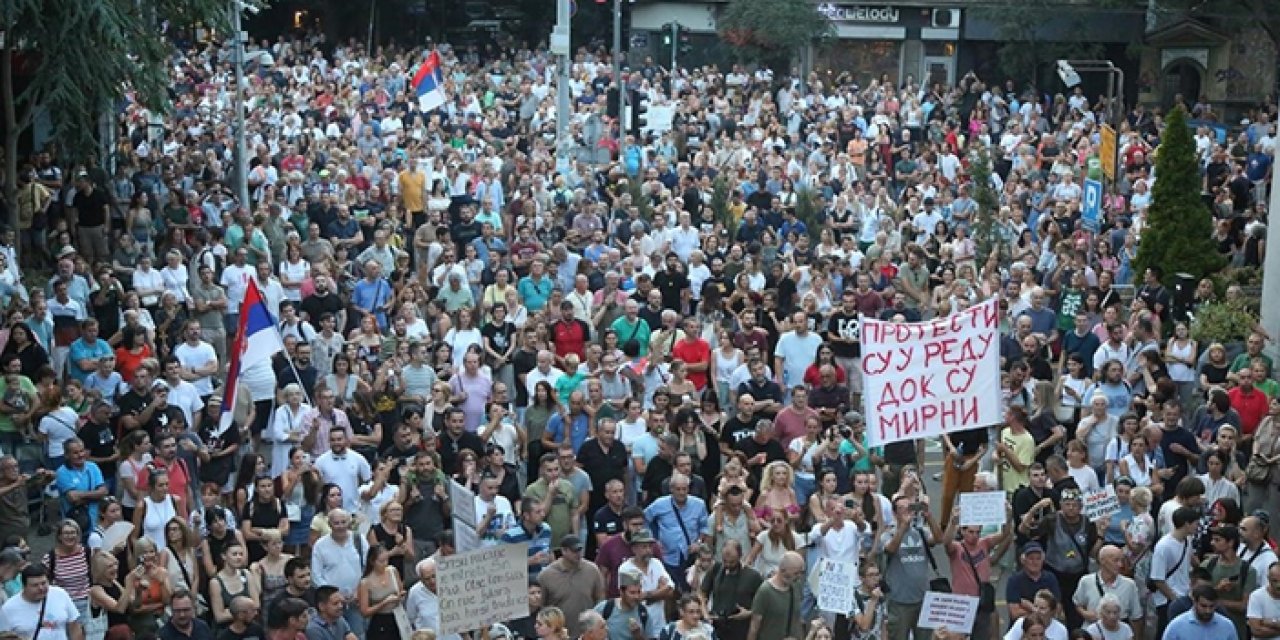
[436,543,529,635]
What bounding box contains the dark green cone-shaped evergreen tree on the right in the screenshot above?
[1134,108,1225,282]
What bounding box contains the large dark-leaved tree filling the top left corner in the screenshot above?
[0,0,235,235]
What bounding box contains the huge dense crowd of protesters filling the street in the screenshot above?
[0,18,1280,640]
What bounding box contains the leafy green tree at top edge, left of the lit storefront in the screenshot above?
[719,0,835,69]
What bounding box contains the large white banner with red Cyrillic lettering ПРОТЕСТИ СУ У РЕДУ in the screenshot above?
[861,298,1004,445]
